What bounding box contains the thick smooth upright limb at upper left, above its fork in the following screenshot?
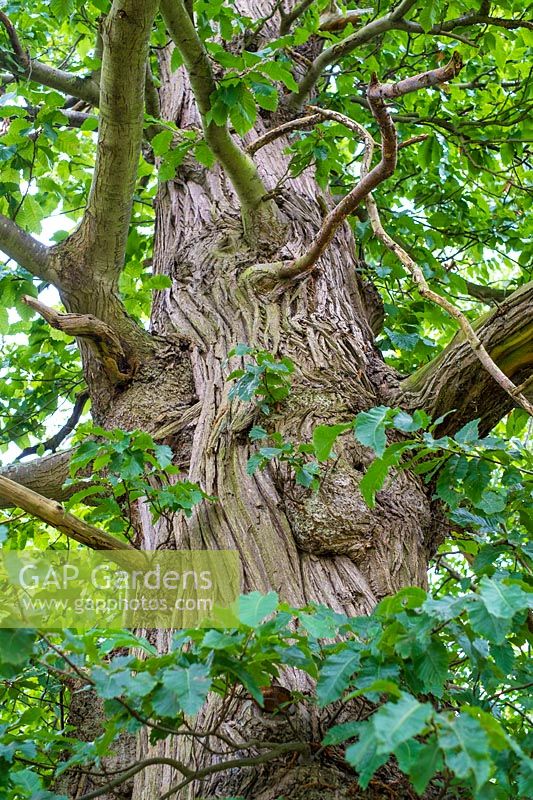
[82,0,159,283]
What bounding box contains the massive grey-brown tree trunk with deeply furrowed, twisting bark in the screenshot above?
[78,28,442,800]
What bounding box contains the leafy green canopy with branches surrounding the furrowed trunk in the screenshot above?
[0,0,533,800]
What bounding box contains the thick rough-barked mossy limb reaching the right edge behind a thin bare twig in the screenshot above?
[394,282,533,430]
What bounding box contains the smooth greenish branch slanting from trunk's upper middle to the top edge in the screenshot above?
[157,0,266,219]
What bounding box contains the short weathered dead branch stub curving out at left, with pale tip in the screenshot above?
[22,295,136,384]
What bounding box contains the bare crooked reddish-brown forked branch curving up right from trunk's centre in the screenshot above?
[243,53,463,289]
